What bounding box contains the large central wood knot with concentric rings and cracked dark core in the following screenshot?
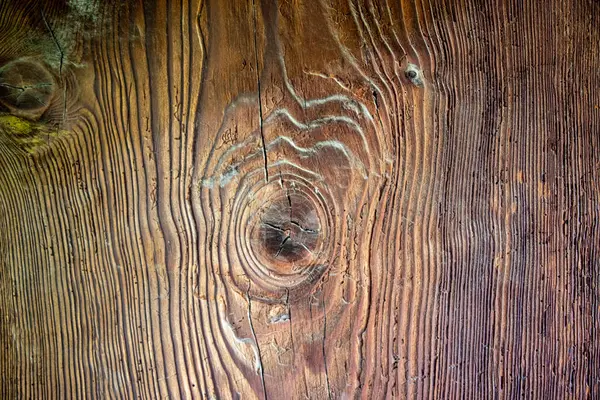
[234,174,332,300]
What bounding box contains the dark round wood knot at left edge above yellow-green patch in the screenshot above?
[0,59,56,120]
